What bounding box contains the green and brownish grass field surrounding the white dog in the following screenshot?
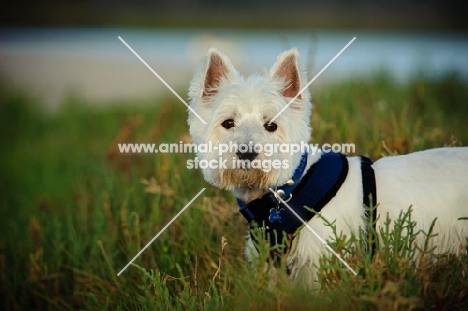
[0,74,468,310]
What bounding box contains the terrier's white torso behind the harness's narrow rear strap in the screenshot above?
[373,147,468,253]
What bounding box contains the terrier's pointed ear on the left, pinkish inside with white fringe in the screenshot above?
[201,48,235,98]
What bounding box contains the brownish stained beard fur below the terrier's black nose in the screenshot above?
[218,169,271,190]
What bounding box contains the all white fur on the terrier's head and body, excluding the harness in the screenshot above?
[188,48,468,284]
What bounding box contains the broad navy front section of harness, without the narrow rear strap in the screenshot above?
[238,152,348,260]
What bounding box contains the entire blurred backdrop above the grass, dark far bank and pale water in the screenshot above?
[0,0,468,109]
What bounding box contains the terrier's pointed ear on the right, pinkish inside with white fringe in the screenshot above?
[270,49,302,99]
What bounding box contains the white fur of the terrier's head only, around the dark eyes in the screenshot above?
[188,49,311,199]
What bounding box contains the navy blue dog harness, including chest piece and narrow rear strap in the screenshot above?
[237,152,377,262]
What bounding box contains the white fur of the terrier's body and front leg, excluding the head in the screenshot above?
[290,151,468,284]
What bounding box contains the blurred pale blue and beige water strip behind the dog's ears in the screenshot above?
[0,28,468,105]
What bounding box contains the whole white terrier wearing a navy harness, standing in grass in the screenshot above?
[188,48,468,285]
